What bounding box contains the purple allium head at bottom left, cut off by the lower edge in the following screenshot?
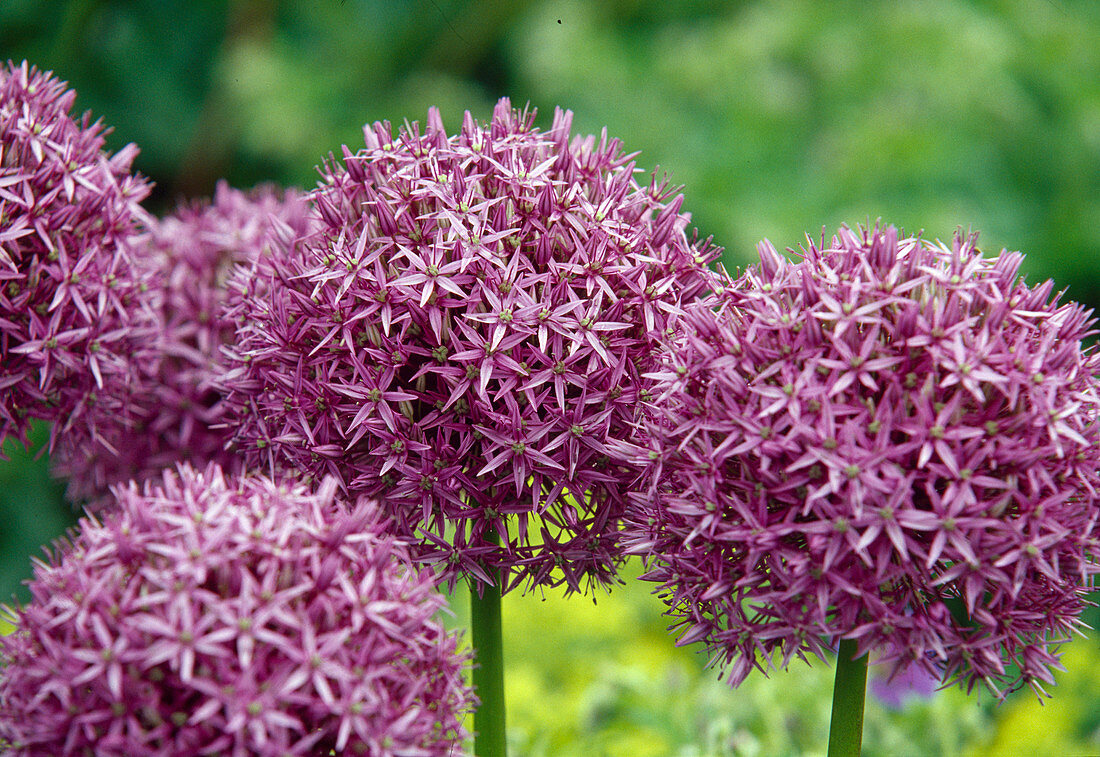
[0,465,472,757]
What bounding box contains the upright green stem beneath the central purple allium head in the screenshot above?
[470,561,507,757]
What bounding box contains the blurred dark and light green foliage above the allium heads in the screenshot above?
[0,0,1100,292]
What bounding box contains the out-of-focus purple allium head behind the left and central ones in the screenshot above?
[54,183,307,501]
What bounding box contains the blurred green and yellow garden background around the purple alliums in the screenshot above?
[0,0,1100,757]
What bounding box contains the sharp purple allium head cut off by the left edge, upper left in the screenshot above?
[0,62,149,444]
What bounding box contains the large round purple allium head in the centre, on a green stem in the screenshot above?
[227,100,716,591]
